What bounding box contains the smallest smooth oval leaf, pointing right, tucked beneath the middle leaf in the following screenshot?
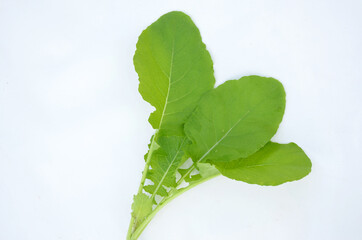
[216,142,312,186]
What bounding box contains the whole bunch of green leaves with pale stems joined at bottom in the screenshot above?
[127,12,311,240]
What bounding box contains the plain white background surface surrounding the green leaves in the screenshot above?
[0,0,362,240]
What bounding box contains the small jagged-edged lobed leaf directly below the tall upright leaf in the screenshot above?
[144,136,188,196]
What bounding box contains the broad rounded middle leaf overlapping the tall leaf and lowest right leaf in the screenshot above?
[185,76,285,163]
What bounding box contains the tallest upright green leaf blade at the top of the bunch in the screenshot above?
[133,12,215,135]
